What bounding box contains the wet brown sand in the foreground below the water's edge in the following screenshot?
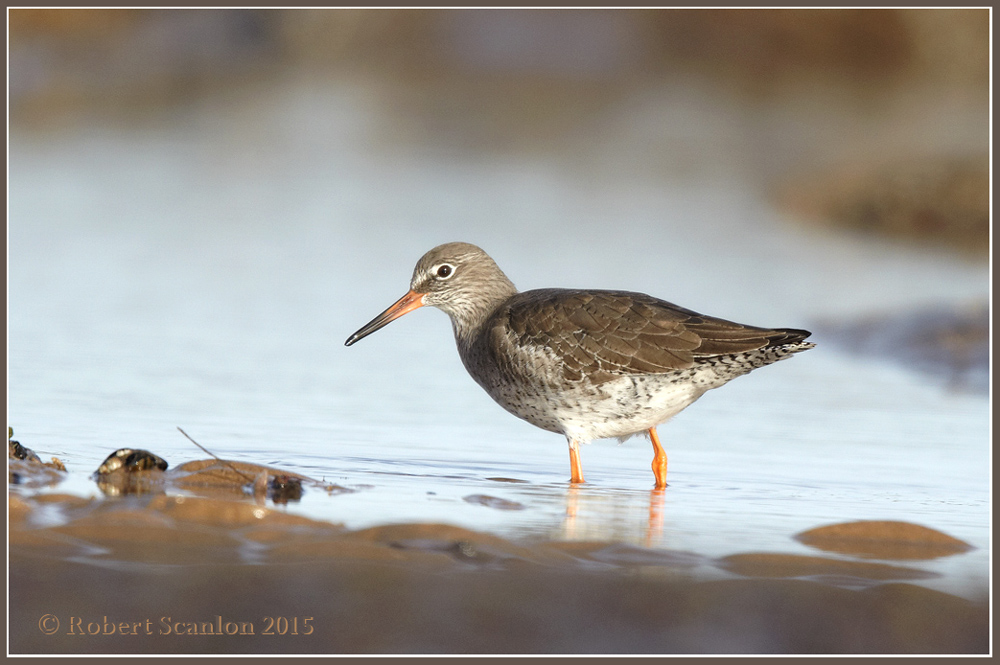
[9,460,989,654]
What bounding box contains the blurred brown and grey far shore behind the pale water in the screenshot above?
[9,9,989,217]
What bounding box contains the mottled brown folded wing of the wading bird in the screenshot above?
[505,289,809,382]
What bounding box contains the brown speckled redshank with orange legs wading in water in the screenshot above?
[346,242,815,488]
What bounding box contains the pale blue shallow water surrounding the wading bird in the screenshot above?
[8,75,990,593]
